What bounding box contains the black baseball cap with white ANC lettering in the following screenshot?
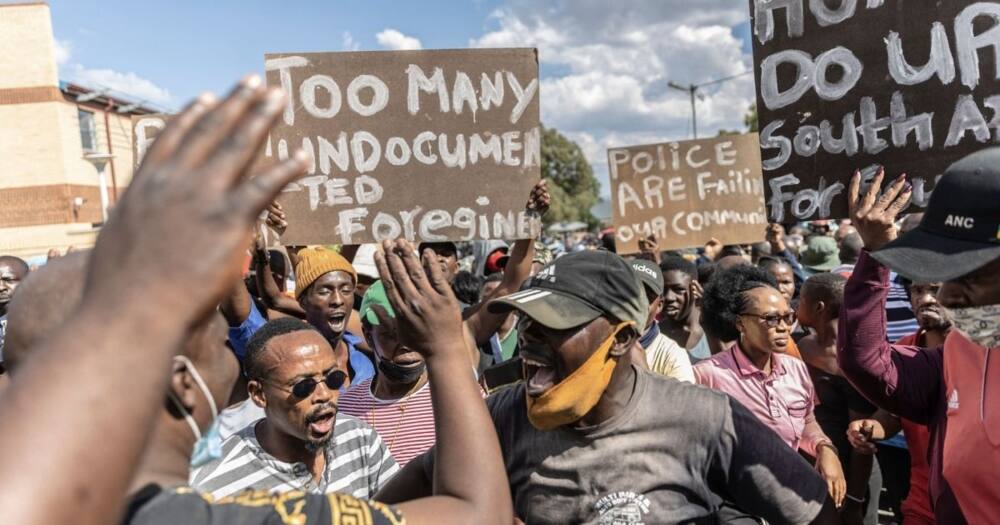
[871,147,1000,282]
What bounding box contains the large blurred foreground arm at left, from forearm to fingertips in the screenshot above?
[0,76,305,524]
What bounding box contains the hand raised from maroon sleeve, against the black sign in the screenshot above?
[847,168,913,251]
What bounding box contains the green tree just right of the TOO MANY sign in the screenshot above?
[542,127,600,227]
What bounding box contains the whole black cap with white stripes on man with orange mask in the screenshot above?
[487,250,649,330]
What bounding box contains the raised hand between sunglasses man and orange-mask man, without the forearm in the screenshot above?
[375,239,468,360]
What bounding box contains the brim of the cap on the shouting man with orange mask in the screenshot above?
[486,288,601,330]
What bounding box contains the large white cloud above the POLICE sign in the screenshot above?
[470,0,754,194]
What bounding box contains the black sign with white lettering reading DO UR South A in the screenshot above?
[750,0,1000,222]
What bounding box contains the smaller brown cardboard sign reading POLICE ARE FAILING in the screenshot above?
[608,134,767,254]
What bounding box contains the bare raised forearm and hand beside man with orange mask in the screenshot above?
[375,240,513,525]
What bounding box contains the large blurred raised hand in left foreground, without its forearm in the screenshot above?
[86,75,305,323]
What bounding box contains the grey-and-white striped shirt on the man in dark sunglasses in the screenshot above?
[190,414,399,499]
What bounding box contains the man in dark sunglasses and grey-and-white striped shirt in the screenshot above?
[191,317,399,499]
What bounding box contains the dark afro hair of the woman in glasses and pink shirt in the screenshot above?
[701,264,778,341]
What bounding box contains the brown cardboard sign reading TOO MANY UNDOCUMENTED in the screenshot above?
[265,49,541,244]
